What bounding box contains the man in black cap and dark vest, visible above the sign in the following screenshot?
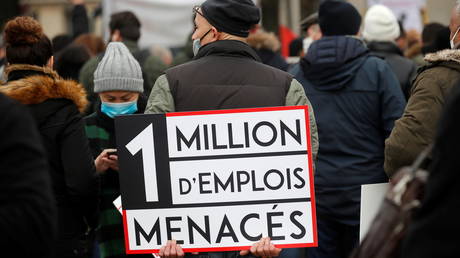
[145,0,319,159]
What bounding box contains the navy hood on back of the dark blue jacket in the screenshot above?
[300,36,369,91]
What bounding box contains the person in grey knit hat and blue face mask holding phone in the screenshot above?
[85,42,152,258]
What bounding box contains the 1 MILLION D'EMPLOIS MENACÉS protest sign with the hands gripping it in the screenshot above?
[116,106,317,257]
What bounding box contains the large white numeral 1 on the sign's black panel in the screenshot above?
[126,124,158,202]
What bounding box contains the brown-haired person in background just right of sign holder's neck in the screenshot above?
[248,28,289,71]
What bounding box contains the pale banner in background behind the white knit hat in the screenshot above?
[367,0,426,33]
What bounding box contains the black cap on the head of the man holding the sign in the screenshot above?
[201,0,260,37]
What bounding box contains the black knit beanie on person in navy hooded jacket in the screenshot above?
[318,0,361,36]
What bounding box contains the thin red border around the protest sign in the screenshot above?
[123,106,318,254]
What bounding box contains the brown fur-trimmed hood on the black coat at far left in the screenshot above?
[0,65,88,113]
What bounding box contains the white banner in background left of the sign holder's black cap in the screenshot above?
[103,0,204,47]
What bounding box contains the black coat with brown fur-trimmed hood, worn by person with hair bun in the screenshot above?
[0,65,99,246]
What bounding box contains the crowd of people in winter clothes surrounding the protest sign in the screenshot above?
[0,0,460,258]
